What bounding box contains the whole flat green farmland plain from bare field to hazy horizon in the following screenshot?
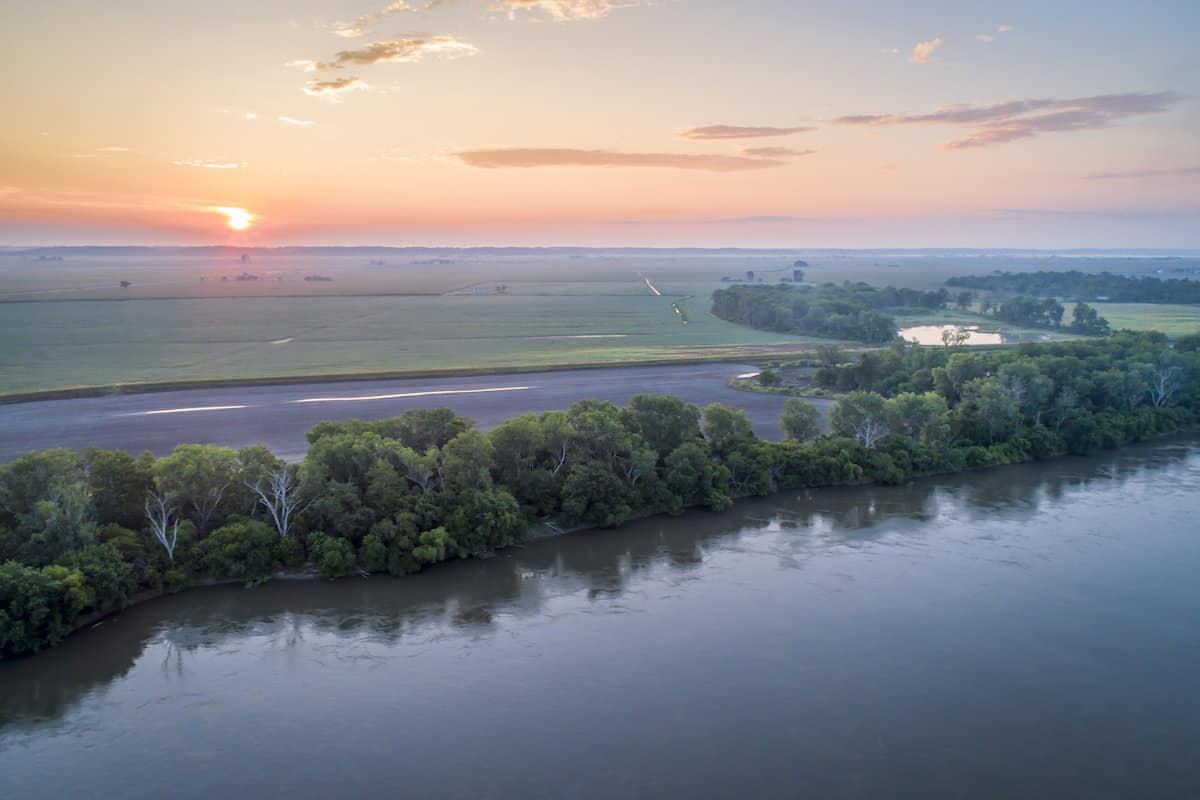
[0,249,1200,395]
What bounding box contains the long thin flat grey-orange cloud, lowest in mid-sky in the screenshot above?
[450,148,787,173]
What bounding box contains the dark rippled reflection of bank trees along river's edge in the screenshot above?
[0,441,1196,741]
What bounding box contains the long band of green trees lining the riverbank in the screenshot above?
[0,332,1200,656]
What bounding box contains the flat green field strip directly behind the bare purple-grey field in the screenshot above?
[0,294,840,395]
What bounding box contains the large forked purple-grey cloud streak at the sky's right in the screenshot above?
[833,91,1182,150]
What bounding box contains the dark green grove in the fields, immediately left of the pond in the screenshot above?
[713,282,950,344]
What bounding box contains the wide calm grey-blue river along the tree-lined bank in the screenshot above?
[0,438,1200,800]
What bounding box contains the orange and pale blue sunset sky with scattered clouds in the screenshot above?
[0,0,1200,248]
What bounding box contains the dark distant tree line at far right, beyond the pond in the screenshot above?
[946,270,1200,303]
